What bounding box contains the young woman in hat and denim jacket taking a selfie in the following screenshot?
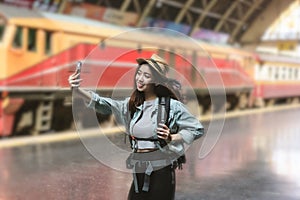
[69,54,203,200]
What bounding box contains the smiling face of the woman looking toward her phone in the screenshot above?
[135,64,153,92]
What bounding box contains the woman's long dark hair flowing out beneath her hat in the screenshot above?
[129,63,181,117]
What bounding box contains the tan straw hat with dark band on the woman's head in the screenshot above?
[136,54,168,77]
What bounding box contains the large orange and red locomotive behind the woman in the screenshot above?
[0,5,300,135]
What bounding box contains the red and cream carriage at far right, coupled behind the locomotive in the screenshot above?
[253,53,300,107]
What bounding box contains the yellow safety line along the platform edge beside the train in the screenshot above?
[0,104,300,149]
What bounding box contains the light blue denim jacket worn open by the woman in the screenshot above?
[88,92,204,154]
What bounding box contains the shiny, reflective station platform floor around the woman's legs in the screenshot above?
[0,108,300,200]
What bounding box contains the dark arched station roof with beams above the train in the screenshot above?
[88,0,297,46]
